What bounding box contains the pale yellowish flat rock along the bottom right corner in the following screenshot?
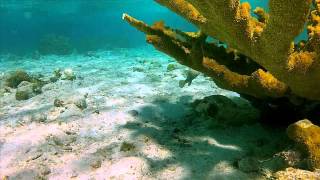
[273,167,320,180]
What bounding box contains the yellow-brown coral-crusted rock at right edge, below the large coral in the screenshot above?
[287,119,320,170]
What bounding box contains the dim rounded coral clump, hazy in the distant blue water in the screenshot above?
[38,34,73,55]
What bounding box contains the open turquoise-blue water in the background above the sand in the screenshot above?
[0,0,304,53]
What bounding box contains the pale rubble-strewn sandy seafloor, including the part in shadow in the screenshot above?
[0,47,288,179]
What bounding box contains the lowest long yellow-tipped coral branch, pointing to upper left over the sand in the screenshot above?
[124,15,288,98]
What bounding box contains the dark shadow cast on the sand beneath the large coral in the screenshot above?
[123,96,285,179]
